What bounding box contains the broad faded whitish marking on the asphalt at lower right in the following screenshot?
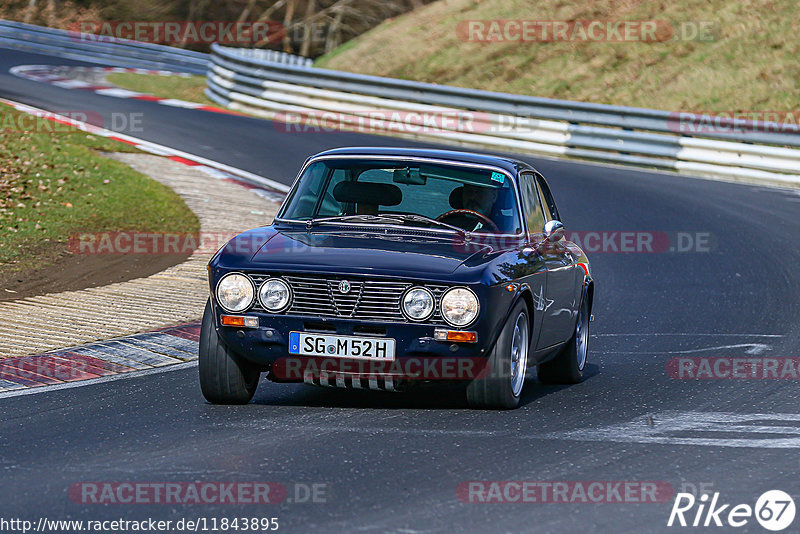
[544,411,800,449]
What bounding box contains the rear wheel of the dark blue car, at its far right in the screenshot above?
[537,290,590,384]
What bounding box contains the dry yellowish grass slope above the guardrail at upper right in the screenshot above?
[316,0,800,112]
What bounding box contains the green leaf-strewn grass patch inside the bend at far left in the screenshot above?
[0,106,199,274]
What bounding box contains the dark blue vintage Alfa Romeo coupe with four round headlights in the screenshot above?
[199,148,594,408]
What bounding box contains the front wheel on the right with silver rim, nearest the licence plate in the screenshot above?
[467,301,530,410]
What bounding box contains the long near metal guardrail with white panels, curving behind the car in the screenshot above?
[206,44,800,184]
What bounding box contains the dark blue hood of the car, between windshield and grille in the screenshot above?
[250,229,490,276]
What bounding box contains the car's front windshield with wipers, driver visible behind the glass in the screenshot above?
[280,158,522,234]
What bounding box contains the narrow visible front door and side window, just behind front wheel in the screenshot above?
[519,173,552,351]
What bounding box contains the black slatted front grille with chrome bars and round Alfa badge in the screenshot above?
[250,274,449,324]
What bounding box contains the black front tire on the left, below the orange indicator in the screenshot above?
[198,302,261,404]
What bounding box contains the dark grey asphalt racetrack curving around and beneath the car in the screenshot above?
[0,49,800,532]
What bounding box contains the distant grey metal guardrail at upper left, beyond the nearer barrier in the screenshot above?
[0,20,311,74]
